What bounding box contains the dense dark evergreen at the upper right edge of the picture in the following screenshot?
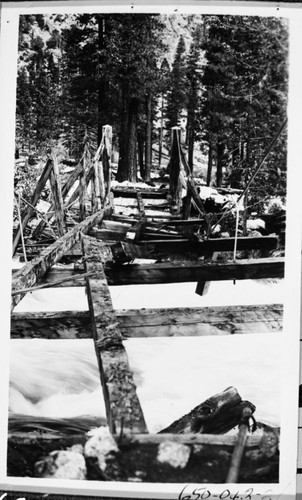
[202,16,288,198]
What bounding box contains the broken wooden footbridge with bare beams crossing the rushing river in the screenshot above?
[8,126,284,483]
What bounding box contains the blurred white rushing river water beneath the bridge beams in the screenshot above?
[9,279,285,432]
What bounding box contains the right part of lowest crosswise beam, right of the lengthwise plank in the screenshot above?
[116,304,283,337]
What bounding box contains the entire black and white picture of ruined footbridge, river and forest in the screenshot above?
[1,2,300,500]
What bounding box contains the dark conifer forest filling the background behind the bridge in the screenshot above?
[15,14,288,213]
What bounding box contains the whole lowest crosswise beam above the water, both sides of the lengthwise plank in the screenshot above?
[11,304,283,339]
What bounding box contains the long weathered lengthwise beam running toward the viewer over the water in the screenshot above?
[83,237,147,433]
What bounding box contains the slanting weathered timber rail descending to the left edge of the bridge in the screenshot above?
[12,209,111,307]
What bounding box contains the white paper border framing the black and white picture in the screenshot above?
[0,0,302,500]
